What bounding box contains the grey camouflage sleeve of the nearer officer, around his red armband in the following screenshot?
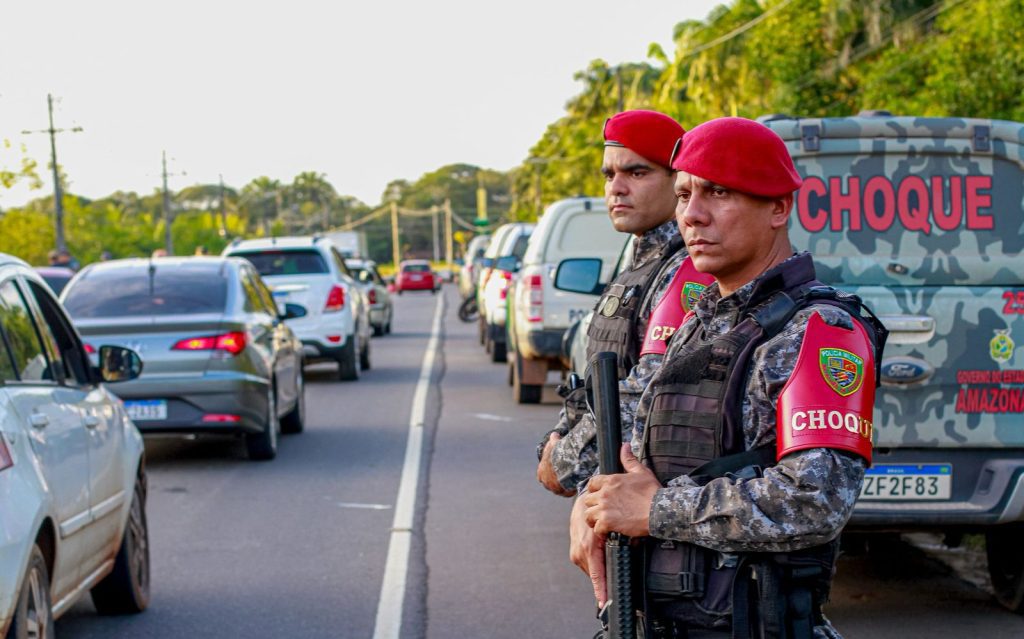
[649,306,864,552]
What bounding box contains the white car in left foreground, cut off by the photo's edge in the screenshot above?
[0,254,150,639]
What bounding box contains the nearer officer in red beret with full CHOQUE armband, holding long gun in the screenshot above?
[571,118,885,639]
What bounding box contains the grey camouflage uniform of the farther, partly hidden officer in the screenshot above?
[542,220,686,489]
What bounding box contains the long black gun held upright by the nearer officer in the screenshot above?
[587,351,636,639]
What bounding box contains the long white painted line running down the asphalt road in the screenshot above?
[373,296,444,639]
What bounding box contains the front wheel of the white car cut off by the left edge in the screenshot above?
[90,475,150,614]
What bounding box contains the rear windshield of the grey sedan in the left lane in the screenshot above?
[63,262,227,320]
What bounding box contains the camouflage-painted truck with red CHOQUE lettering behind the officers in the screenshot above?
[763,113,1024,611]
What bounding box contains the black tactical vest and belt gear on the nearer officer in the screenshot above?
[642,254,885,639]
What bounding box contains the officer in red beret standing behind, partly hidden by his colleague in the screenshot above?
[537,111,711,497]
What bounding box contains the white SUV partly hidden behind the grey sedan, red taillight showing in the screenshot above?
[223,236,372,381]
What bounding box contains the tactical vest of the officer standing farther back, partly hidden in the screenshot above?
[587,236,683,379]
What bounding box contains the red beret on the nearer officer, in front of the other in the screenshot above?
[672,118,804,198]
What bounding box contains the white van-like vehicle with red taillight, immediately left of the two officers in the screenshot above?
[506,198,624,403]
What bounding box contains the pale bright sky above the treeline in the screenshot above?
[0,0,720,208]
